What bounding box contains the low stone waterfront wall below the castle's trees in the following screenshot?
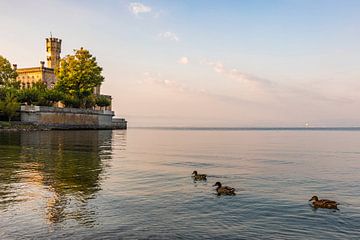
[21,106,126,129]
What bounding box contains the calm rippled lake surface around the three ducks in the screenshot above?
[0,129,360,239]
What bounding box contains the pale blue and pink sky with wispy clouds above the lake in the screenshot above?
[0,0,360,127]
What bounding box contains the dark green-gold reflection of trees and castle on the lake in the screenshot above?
[0,131,118,229]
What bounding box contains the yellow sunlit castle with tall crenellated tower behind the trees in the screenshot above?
[14,37,100,94]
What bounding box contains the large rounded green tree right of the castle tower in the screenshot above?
[55,48,104,108]
